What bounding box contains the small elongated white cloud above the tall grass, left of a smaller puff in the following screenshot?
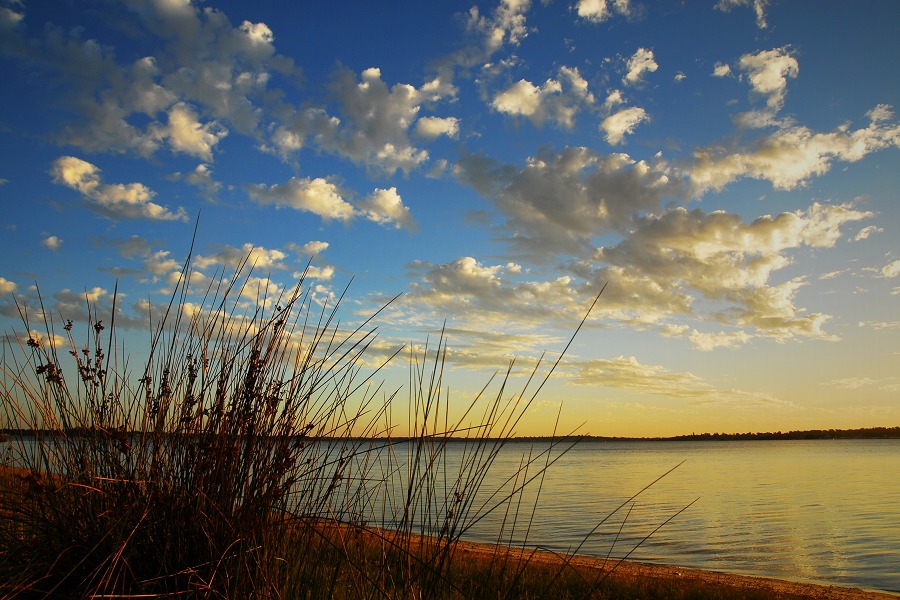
[245,177,356,222]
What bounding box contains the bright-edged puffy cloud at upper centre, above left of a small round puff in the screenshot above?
[491,67,595,129]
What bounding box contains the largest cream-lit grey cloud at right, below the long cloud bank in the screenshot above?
[583,203,873,342]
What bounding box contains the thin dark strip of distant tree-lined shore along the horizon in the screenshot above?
[0,427,900,443]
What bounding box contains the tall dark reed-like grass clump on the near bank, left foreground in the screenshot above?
[0,250,652,598]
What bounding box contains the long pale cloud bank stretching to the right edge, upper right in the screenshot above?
[687,105,900,196]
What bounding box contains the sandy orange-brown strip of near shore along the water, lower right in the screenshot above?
[446,541,900,600]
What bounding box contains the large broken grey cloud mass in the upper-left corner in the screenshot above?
[5,2,297,156]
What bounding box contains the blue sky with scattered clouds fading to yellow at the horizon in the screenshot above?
[0,0,900,436]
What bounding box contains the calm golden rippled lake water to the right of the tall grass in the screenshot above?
[451,440,900,592]
